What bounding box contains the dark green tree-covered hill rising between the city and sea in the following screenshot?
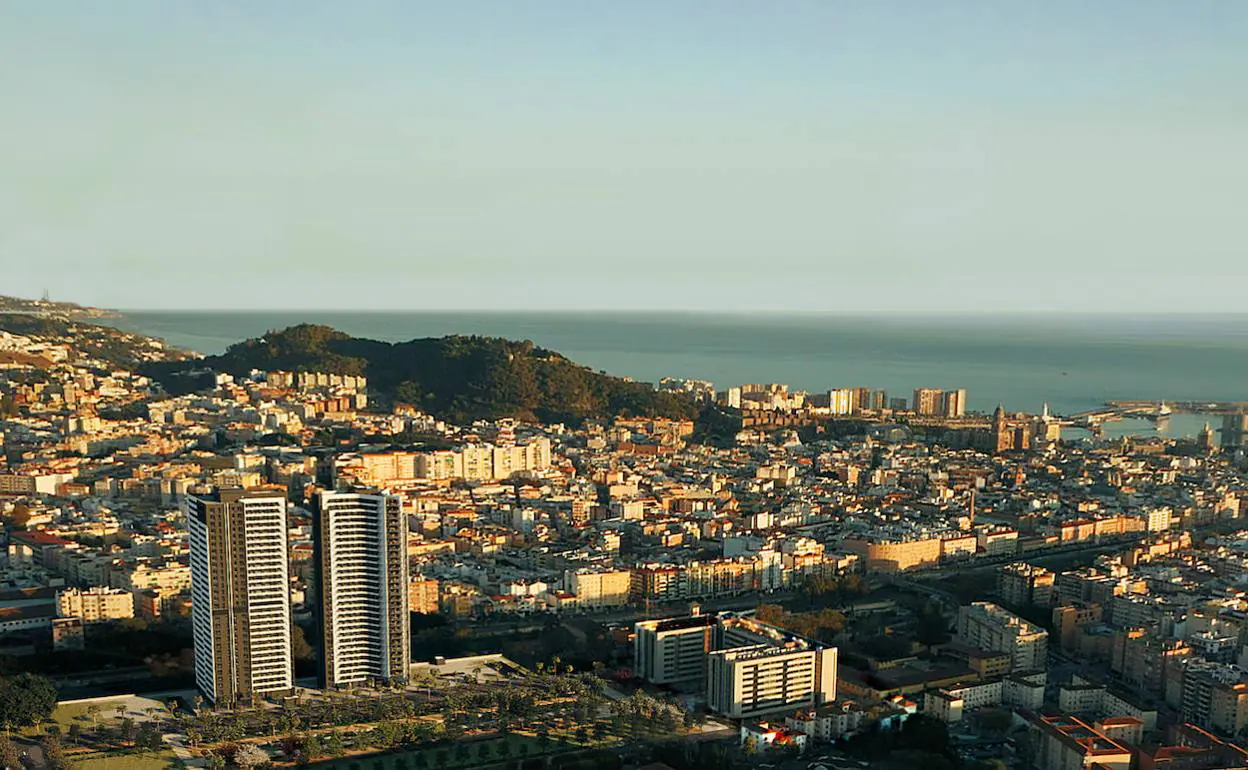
[146,324,698,422]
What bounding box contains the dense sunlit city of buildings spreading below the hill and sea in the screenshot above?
[0,313,1248,770]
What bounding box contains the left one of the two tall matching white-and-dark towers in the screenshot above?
[185,488,295,706]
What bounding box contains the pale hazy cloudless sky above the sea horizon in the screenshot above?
[0,0,1248,311]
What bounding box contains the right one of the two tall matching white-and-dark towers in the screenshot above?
[313,492,411,688]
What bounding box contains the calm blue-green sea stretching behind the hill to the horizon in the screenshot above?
[107,311,1248,436]
